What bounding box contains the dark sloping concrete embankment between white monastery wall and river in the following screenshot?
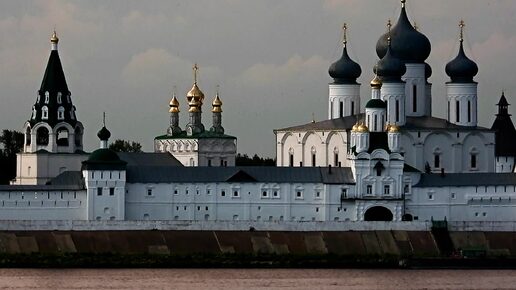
[0,230,516,267]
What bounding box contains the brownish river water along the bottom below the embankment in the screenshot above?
[0,269,516,290]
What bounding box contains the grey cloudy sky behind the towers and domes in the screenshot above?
[0,0,516,157]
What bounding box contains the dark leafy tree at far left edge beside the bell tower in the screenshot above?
[0,130,23,184]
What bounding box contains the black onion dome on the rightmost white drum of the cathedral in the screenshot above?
[446,41,478,83]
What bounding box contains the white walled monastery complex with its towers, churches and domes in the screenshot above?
[0,0,516,223]
